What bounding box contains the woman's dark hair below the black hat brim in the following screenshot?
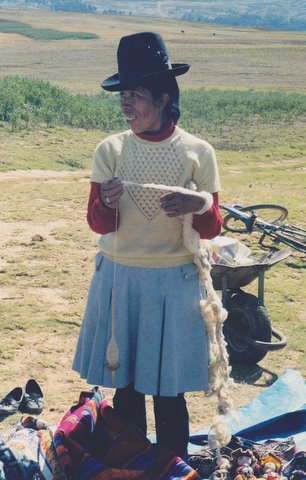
[141,75,181,123]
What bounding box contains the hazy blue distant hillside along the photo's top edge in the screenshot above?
[0,0,306,31]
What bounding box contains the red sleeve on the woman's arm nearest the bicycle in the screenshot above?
[192,193,223,240]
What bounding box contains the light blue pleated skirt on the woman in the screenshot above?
[72,253,209,396]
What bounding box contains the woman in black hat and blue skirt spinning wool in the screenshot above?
[73,32,222,457]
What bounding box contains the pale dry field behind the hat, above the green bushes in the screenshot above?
[0,9,306,93]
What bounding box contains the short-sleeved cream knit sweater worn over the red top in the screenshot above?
[91,127,220,268]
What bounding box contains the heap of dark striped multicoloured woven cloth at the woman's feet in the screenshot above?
[54,388,199,480]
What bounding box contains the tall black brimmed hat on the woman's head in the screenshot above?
[101,32,189,92]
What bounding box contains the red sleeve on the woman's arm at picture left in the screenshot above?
[87,182,119,235]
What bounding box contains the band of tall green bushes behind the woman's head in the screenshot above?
[0,77,306,133]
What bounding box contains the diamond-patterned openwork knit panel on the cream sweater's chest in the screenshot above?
[120,139,184,220]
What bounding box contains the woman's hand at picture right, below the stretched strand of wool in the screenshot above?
[160,188,205,217]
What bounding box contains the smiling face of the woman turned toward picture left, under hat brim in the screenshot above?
[120,87,169,133]
